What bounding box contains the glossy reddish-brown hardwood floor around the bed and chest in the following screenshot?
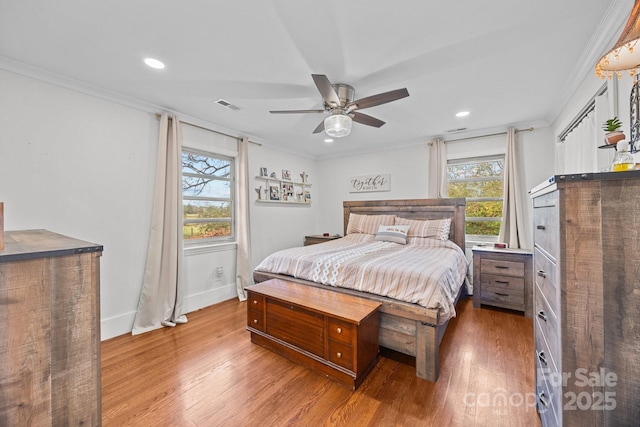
[102,299,540,427]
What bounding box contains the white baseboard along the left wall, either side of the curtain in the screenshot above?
[100,283,237,341]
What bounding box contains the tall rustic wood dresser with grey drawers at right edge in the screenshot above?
[531,171,640,426]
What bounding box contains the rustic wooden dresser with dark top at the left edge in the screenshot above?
[0,230,102,426]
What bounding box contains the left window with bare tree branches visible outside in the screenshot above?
[182,149,234,244]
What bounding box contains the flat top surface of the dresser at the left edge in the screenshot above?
[0,230,102,263]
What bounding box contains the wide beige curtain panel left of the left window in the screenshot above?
[131,113,187,335]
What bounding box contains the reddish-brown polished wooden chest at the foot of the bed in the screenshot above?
[247,279,380,390]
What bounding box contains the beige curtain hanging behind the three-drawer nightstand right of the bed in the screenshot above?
[498,128,529,248]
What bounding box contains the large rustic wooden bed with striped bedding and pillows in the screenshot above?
[253,198,467,382]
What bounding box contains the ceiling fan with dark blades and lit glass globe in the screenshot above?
[270,74,409,138]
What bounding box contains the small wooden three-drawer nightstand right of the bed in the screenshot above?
[472,246,533,317]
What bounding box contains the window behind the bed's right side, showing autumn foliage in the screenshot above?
[447,155,504,240]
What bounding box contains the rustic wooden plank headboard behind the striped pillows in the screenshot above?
[342,198,466,251]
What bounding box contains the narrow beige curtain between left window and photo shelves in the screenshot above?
[235,138,253,301]
